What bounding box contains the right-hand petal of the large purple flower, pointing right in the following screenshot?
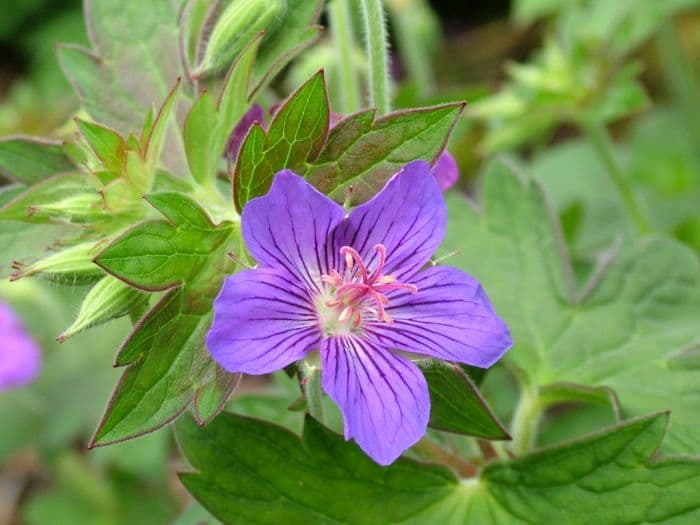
[367,266,513,368]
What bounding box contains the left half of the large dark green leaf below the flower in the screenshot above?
[177,413,454,525]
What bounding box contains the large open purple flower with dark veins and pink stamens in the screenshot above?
[207,161,511,465]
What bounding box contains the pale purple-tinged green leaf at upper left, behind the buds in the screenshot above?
[58,0,187,173]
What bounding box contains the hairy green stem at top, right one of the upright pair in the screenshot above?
[360,0,391,115]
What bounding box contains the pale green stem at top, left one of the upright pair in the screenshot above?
[328,0,360,114]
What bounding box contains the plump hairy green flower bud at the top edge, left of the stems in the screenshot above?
[194,0,287,76]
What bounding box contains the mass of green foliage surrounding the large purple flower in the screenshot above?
[0,0,700,525]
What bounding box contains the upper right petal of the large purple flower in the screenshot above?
[338,161,447,281]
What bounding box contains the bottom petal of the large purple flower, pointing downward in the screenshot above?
[321,337,430,465]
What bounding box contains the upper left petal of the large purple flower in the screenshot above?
[242,170,345,290]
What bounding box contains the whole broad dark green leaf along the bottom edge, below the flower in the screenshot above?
[177,414,700,525]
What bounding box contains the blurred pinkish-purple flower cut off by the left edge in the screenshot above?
[0,301,41,391]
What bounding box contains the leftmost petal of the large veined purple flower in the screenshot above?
[207,269,321,375]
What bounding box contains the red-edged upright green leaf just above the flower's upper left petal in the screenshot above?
[233,71,330,211]
